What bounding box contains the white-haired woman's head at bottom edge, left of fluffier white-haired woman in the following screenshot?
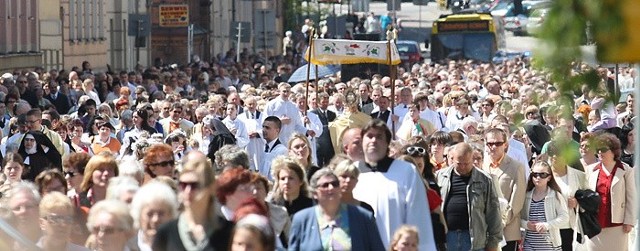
[87,200,133,251]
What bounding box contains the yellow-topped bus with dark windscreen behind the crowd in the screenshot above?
[430,13,506,62]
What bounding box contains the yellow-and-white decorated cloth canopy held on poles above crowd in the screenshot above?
[305,39,400,65]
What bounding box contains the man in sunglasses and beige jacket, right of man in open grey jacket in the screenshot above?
[482,128,526,251]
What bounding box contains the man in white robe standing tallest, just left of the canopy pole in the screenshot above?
[263,83,307,144]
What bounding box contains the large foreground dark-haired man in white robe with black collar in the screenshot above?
[353,119,436,251]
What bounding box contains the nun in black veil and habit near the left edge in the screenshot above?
[18,131,62,181]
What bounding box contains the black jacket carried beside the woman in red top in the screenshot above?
[575,189,602,238]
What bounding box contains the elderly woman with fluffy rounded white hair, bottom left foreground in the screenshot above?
[131,181,178,251]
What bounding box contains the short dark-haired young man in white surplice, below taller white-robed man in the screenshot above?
[259,116,288,181]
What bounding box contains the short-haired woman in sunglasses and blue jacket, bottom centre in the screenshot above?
[289,168,384,251]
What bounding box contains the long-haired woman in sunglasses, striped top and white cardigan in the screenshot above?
[520,161,569,250]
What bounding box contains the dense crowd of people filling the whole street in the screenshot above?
[0,45,637,251]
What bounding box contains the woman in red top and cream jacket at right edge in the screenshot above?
[585,133,636,251]
